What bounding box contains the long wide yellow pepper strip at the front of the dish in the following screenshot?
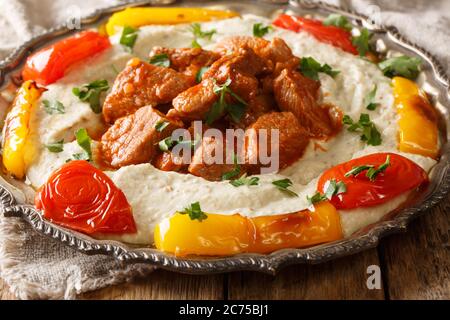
[154,202,342,256]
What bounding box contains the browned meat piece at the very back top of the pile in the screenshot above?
[216,36,300,75]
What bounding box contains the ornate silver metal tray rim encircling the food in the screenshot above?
[0,0,450,274]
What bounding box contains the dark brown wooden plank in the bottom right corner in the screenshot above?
[380,195,450,299]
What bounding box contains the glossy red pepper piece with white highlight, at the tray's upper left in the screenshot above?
[22,31,111,86]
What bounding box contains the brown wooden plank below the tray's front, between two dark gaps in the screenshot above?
[228,249,384,300]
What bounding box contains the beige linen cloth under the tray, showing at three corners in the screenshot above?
[0,0,450,299]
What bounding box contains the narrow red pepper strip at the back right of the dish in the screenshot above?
[273,14,358,55]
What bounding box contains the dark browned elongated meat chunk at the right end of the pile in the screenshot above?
[273,69,336,138]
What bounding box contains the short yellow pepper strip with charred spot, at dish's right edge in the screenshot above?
[392,77,439,158]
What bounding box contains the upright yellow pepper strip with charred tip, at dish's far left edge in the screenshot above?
[3,81,44,179]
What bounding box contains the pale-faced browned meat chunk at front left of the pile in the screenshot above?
[102,106,183,168]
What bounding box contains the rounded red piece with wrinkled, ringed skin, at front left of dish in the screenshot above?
[35,160,136,234]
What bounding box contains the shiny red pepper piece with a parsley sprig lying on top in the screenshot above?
[317,153,428,209]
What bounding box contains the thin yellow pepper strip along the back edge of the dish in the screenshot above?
[106,7,239,36]
